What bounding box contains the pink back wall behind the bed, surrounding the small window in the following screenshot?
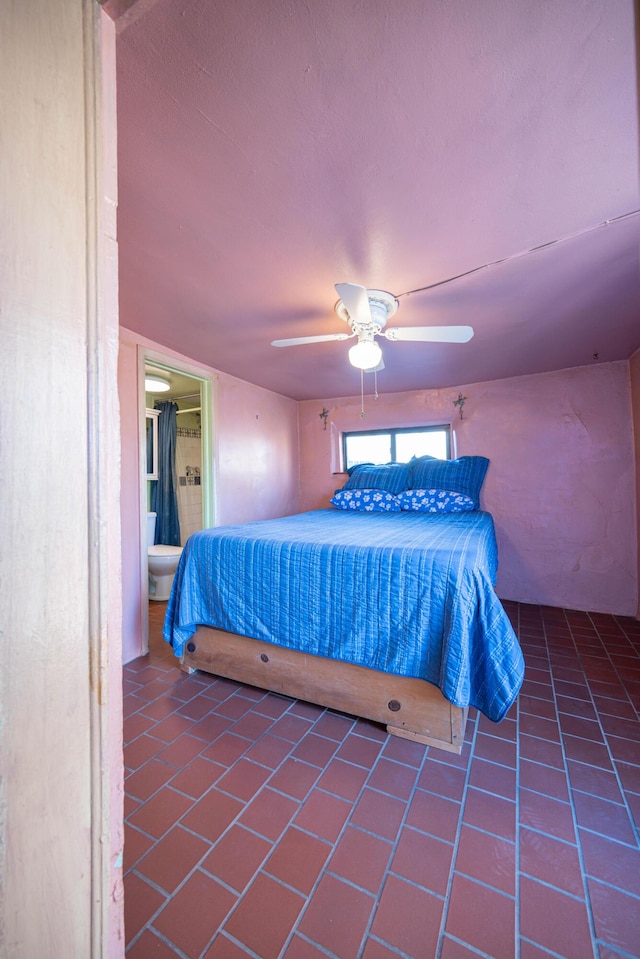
[299,362,640,615]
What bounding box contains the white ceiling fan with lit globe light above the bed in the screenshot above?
[271,283,473,371]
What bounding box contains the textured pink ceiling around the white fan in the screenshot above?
[117,0,640,399]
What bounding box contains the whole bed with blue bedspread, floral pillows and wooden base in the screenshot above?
[164,458,524,752]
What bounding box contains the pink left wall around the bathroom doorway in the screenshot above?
[118,327,299,663]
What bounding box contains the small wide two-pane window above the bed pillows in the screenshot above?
[342,426,450,470]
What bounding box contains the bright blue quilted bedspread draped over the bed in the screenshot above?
[164,509,524,721]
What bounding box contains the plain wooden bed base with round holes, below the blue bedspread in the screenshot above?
[180,626,467,753]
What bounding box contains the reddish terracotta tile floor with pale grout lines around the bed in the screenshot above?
[124,603,640,959]
